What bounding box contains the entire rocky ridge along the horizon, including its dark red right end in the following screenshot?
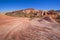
[5,8,58,18]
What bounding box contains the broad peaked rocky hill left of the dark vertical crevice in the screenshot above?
[5,8,42,18]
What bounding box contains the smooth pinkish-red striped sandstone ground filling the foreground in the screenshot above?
[0,16,60,40]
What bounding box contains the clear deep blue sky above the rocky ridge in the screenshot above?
[0,0,60,12]
